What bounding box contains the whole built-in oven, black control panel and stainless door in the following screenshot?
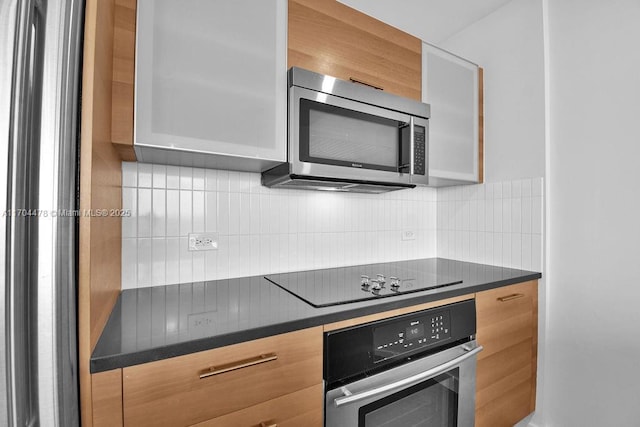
[324,300,482,427]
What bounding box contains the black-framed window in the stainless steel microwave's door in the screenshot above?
[299,99,407,172]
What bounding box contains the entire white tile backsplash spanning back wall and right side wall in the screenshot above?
[122,162,544,289]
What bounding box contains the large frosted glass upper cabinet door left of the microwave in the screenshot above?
[134,0,287,171]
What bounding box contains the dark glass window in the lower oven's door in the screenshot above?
[358,368,459,427]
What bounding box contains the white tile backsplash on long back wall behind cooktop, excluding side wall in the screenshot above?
[122,162,440,289]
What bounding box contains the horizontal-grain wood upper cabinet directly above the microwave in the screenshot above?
[288,0,422,100]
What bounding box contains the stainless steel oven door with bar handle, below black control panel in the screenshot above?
[325,341,482,427]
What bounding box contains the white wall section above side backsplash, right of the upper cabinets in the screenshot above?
[438,0,545,182]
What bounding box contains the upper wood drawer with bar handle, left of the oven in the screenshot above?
[123,327,322,426]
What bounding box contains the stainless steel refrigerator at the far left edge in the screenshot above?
[0,0,84,426]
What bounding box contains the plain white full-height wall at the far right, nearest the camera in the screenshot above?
[535,0,640,427]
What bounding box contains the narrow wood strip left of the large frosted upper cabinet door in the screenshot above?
[111,0,136,161]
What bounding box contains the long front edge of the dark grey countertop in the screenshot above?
[90,273,542,374]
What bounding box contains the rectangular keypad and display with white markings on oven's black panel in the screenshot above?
[373,310,451,361]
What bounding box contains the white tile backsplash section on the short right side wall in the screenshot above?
[436,177,544,271]
